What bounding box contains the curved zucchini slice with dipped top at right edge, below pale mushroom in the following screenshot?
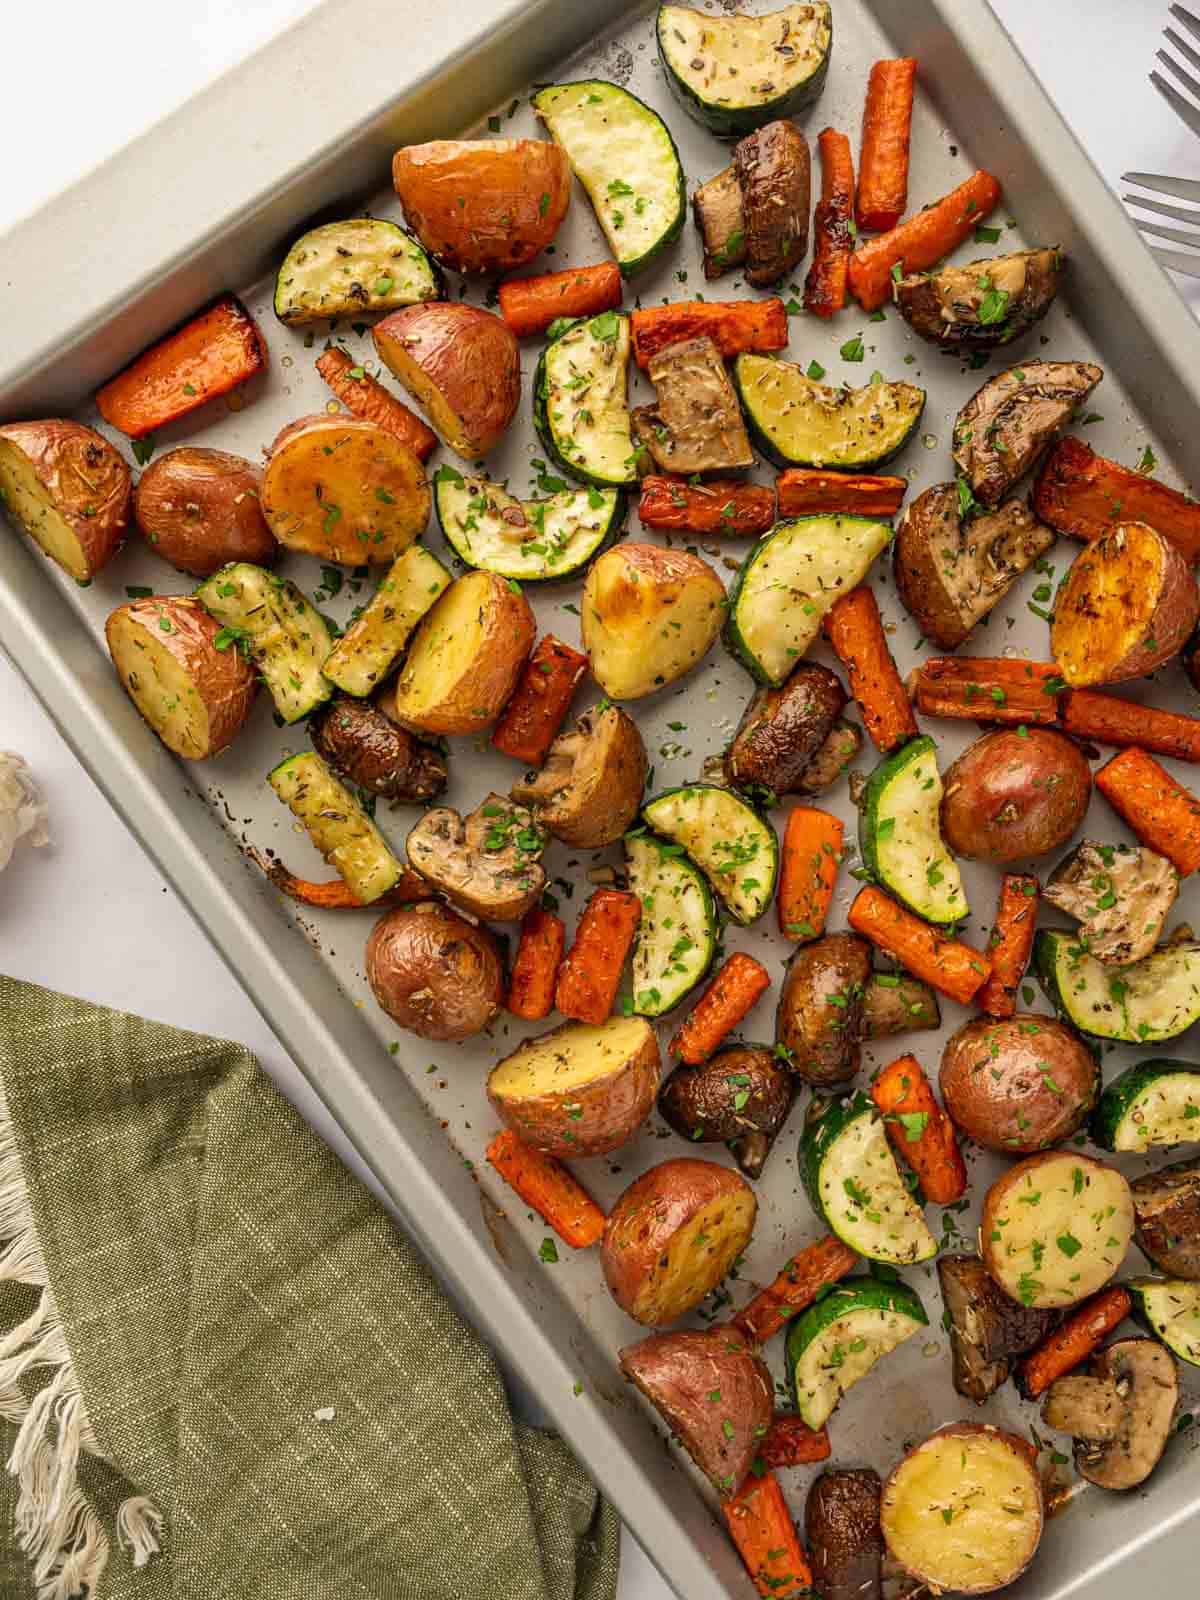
[1034,928,1200,1045]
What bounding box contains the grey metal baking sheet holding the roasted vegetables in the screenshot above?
[0,0,1200,1600]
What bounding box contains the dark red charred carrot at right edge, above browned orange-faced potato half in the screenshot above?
[1032,437,1200,562]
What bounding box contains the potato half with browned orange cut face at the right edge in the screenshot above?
[1050,522,1200,688]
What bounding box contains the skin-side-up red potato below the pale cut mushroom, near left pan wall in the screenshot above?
[366,901,504,1040]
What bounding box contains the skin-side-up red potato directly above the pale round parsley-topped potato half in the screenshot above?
[939,1011,1101,1155]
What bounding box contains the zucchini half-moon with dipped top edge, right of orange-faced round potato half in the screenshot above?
[434,466,624,582]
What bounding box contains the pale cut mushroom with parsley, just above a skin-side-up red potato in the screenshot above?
[405,794,546,922]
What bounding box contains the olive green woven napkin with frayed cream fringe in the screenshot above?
[0,976,619,1600]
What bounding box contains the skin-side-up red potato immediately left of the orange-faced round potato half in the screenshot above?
[133,445,278,578]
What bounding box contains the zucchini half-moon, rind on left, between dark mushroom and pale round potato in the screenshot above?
[800,1093,938,1267]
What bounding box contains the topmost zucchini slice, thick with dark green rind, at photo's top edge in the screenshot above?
[658,0,834,136]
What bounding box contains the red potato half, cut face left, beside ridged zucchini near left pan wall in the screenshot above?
[104,595,258,762]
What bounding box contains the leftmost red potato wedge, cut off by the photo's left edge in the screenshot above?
[0,418,133,582]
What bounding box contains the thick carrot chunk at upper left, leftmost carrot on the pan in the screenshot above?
[96,294,267,438]
